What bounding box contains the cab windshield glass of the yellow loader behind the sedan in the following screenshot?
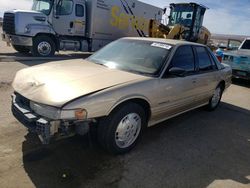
[169,5,194,26]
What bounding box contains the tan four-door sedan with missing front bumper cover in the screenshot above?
[12,38,231,154]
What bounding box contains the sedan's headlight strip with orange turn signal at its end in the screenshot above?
[30,102,87,120]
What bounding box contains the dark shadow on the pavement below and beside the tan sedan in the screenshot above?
[22,103,250,188]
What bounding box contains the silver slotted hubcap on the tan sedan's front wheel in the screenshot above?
[115,113,141,148]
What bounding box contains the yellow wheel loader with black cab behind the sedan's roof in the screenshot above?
[149,3,211,44]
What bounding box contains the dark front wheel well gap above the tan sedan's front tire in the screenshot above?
[112,98,151,121]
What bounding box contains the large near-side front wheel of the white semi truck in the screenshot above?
[32,36,55,57]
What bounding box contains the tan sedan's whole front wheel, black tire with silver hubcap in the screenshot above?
[97,103,146,154]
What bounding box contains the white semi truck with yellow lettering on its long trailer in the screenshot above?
[2,0,163,57]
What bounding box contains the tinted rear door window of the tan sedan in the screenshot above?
[195,47,214,71]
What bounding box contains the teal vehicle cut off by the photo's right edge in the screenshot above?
[223,38,250,80]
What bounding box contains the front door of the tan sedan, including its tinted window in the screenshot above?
[151,45,200,121]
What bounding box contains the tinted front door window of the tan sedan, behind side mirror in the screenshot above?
[170,46,194,72]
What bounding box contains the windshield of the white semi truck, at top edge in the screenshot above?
[32,0,53,15]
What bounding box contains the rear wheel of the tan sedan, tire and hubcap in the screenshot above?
[207,84,224,111]
